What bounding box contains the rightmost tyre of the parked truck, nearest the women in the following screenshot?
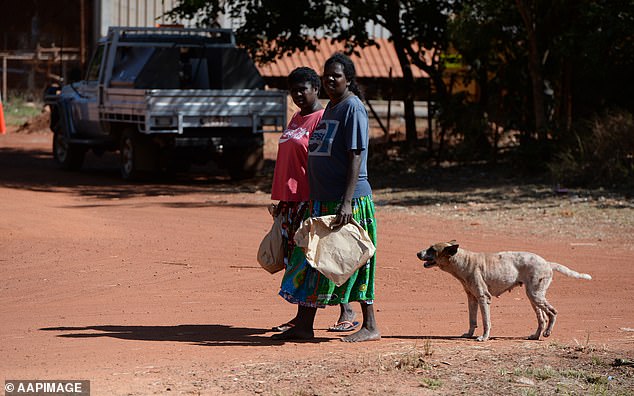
[223,135,264,180]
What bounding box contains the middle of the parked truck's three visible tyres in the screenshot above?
[119,129,159,180]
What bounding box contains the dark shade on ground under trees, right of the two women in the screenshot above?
[368,148,634,212]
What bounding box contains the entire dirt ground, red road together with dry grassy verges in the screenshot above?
[0,122,634,395]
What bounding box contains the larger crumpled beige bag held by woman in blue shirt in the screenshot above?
[295,215,376,286]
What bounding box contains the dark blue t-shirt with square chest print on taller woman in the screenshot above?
[308,95,372,201]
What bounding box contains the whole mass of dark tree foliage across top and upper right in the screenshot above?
[171,0,634,184]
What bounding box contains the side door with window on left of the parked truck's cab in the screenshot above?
[73,45,104,136]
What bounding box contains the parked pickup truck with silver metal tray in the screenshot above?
[44,27,287,179]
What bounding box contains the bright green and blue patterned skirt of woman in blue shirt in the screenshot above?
[279,195,376,308]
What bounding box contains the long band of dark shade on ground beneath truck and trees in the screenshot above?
[0,135,634,211]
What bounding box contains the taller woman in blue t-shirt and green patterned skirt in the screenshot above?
[273,53,381,342]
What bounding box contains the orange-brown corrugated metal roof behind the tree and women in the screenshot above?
[258,38,427,78]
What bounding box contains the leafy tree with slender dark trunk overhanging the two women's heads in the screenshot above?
[169,0,459,142]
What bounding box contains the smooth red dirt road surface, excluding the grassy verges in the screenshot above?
[0,129,634,395]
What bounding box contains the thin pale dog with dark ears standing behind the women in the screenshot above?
[417,241,592,341]
